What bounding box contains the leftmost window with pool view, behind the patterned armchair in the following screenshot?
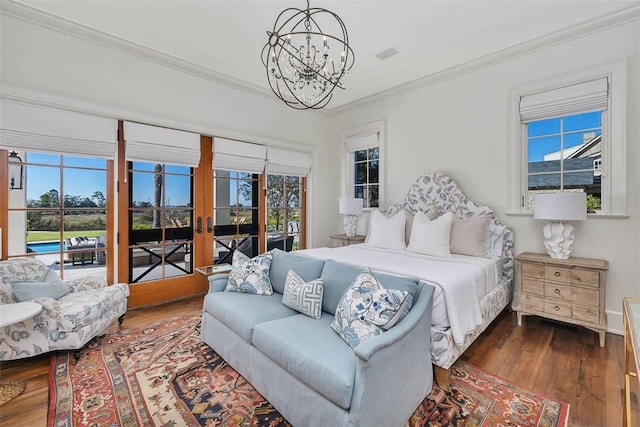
[8,152,109,280]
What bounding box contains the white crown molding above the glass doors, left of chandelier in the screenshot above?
[0,0,273,99]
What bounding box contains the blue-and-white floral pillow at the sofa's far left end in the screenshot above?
[224,250,273,295]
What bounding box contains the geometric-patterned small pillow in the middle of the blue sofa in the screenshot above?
[282,270,324,319]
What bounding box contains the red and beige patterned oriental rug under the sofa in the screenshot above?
[47,314,569,427]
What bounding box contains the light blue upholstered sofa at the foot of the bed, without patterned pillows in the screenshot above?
[202,250,434,427]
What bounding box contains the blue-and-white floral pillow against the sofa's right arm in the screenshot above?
[331,271,413,348]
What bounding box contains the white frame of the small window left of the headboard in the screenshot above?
[340,120,387,211]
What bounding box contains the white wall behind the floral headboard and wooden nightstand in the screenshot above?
[333,21,640,332]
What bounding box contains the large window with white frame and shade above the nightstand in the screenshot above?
[509,63,626,215]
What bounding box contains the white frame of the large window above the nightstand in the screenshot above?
[507,61,628,217]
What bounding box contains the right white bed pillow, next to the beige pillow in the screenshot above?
[407,212,453,257]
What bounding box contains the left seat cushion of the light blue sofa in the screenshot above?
[204,292,298,344]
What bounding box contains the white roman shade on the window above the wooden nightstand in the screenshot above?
[520,77,609,123]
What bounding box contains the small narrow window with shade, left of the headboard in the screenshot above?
[343,122,384,208]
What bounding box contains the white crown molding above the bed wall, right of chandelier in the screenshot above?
[327,4,640,115]
